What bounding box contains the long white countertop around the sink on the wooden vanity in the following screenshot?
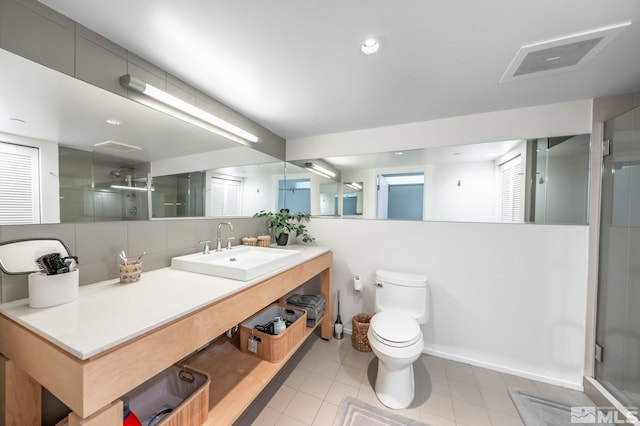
[0,245,330,359]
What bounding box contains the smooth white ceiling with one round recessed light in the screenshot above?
[41,0,640,139]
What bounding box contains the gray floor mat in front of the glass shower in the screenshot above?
[509,388,613,426]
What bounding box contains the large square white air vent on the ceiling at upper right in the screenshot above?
[500,21,631,83]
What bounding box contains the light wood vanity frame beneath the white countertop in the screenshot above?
[0,251,333,426]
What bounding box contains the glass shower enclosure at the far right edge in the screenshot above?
[595,107,640,407]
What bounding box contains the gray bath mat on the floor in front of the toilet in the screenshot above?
[333,397,428,426]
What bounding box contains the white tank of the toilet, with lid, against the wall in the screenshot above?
[375,270,430,324]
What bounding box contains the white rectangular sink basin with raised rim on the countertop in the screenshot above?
[171,246,302,281]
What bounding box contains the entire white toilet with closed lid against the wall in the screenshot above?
[367,271,429,409]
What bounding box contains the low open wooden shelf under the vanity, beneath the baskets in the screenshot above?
[192,325,317,426]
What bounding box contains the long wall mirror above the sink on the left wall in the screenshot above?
[0,49,284,224]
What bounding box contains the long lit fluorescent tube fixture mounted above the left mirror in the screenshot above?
[120,74,258,143]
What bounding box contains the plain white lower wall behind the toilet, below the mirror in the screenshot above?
[300,217,588,389]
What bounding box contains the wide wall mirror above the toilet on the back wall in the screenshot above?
[298,134,590,225]
